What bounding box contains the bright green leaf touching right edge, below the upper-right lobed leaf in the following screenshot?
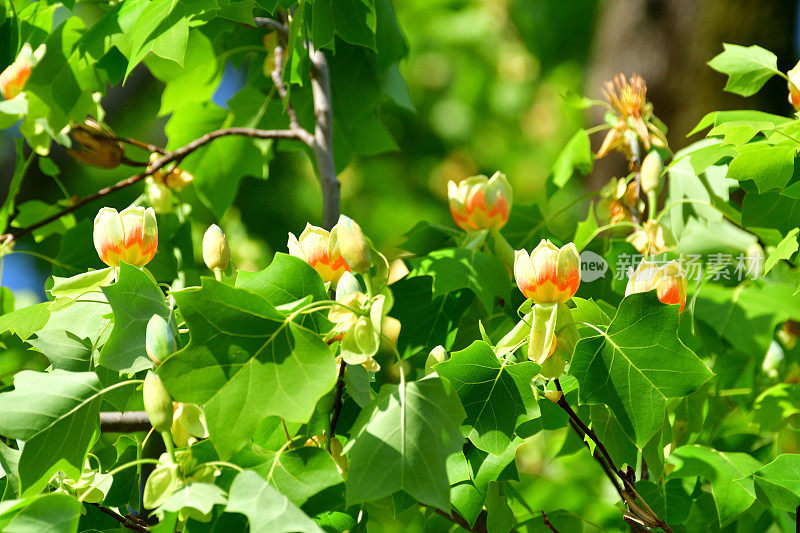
[725,143,797,193]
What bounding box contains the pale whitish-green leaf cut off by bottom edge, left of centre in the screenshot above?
[225,472,323,533]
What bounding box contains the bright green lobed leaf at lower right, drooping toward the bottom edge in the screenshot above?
[668,444,761,527]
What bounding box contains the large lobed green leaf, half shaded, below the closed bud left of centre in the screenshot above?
[159,278,336,459]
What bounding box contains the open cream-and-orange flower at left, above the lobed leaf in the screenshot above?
[94,207,158,267]
